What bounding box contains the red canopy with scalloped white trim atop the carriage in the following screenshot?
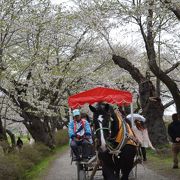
[68,87,132,109]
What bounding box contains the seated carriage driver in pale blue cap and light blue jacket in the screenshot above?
[68,109,92,161]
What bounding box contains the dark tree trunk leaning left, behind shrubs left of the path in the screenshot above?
[0,85,55,148]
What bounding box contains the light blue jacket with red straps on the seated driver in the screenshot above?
[68,119,92,143]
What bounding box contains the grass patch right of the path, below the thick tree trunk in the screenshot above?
[145,145,180,180]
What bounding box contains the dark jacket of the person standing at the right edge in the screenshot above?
[168,121,180,143]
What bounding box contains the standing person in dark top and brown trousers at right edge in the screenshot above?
[168,113,180,169]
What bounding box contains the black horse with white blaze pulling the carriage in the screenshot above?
[89,103,137,180]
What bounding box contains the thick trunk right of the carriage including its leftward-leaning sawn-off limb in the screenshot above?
[112,55,168,146]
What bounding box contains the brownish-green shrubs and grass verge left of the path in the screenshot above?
[0,130,69,180]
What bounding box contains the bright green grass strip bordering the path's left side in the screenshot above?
[23,145,69,180]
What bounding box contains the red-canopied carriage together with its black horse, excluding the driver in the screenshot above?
[68,87,137,180]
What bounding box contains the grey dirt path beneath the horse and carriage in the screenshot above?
[42,151,174,180]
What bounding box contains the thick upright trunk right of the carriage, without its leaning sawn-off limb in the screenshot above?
[139,81,168,146]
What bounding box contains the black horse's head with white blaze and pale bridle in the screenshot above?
[89,103,114,151]
